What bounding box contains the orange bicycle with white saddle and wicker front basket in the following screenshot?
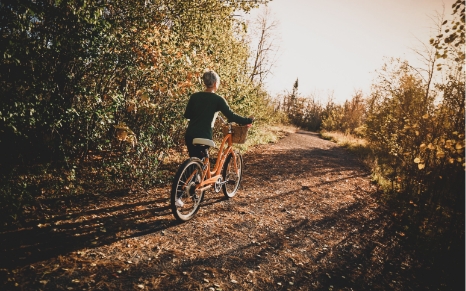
[170,116,250,221]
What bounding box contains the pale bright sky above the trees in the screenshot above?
[245,0,455,104]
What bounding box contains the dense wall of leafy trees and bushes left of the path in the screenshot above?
[0,0,273,224]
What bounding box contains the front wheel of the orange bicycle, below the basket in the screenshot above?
[222,152,243,198]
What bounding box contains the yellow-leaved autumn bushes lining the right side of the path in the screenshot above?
[323,1,465,261]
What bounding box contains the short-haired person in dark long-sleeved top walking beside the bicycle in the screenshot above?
[184,70,254,158]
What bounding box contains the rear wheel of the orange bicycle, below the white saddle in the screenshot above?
[170,158,204,221]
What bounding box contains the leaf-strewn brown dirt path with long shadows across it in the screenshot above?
[0,131,434,290]
